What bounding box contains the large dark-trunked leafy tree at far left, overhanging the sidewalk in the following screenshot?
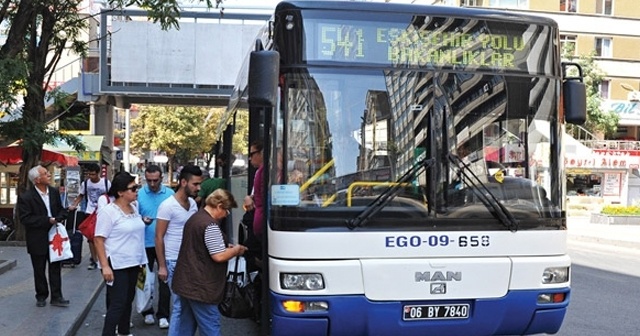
[0,0,221,239]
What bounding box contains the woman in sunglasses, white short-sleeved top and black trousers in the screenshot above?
[94,173,147,336]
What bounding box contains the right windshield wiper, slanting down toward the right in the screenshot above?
[447,153,518,232]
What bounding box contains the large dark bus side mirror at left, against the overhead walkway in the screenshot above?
[248,42,280,107]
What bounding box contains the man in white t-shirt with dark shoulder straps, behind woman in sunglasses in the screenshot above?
[69,163,111,270]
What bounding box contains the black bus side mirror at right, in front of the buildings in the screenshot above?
[562,62,587,125]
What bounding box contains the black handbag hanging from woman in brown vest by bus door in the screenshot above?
[218,256,255,319]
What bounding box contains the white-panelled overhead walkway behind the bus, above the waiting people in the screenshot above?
[90,10,269,108]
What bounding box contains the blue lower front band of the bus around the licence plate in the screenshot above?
[271,288,570,336]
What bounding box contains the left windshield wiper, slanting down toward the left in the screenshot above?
[346,157,436,230]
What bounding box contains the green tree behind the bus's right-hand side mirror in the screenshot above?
[563,45,620,137]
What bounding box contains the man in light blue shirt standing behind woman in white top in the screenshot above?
[138,165,174,329]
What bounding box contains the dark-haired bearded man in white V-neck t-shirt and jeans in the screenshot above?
[156,165,203,335]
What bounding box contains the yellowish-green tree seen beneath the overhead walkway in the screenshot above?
[131,106,215,182]
